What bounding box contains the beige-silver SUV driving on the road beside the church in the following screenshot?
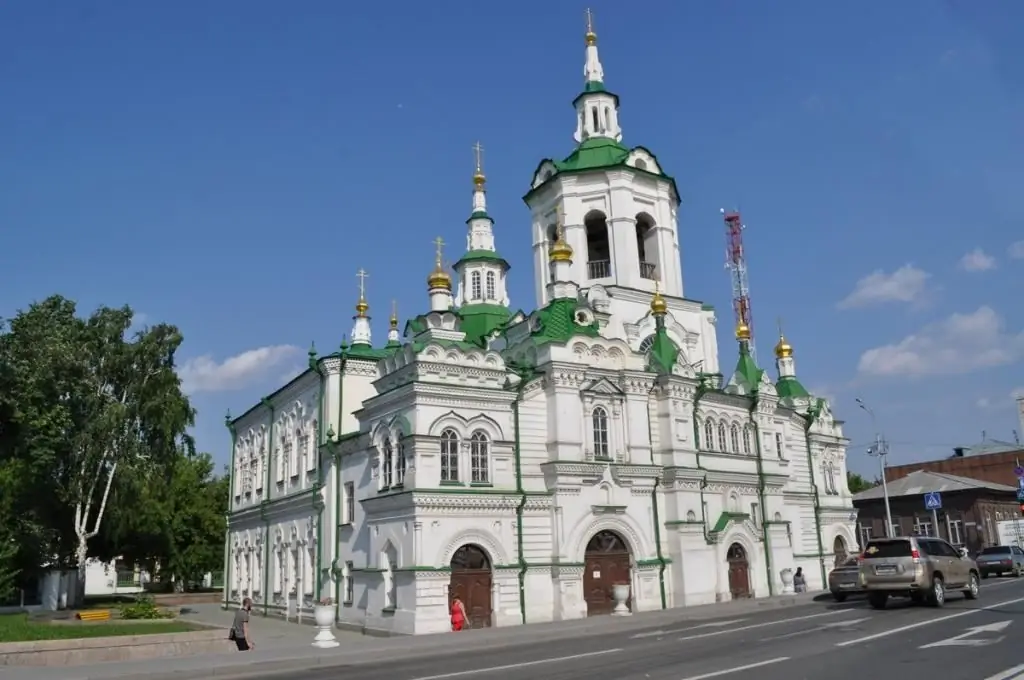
[860,536,980,609]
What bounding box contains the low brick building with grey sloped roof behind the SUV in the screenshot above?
[853,466,1020,553]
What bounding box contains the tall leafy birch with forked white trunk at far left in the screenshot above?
[0,296,195,602]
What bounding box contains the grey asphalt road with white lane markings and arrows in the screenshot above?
[266,579,1024,680]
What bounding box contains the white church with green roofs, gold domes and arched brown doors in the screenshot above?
[224,18,857,634]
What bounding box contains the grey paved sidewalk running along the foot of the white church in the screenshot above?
[3,593,822,680]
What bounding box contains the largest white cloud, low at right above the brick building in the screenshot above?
[857,306,1024,376]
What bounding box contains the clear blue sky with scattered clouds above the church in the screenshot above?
[0,0,1024,471]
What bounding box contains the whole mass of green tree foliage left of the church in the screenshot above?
[0,296,226,588]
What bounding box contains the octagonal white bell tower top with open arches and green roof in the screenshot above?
[523,10,683,318]
